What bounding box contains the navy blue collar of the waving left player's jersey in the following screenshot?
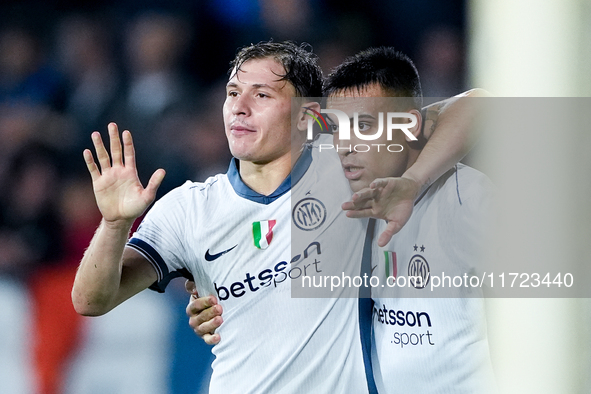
[226,144,312,205]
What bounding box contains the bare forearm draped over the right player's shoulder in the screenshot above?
[402,89,489,194]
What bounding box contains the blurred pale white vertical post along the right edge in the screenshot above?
[468,0,591,393]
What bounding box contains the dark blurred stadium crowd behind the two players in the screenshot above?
[0,0,466,394]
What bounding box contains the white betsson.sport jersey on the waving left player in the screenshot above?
[128,136,368,394]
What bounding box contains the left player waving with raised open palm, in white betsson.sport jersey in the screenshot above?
[72,43,486,393]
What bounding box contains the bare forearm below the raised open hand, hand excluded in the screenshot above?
[72,220,133,316]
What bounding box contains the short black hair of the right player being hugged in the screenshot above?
[323,47,423,109]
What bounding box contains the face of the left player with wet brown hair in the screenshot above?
[223,58,296,164]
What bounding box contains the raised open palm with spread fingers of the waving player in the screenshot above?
[84,123,165,222]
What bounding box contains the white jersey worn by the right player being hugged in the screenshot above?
[372,164,495,394]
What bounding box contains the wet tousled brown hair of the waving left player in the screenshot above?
[229,41,322,97]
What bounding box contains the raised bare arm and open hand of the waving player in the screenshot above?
[72,123,165,316]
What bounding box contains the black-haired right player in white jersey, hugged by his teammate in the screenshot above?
[325,48,494,393]
